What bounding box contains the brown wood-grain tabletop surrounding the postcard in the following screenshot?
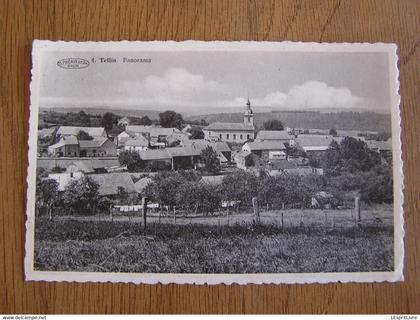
[0,0,420,314]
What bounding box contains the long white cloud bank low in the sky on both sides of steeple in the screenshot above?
[40,76,367,109]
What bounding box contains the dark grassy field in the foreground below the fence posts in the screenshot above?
[34,218,393,273]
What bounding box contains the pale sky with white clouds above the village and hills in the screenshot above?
[40,51,390,113]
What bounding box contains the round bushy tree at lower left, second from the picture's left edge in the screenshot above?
[63,176,99,214]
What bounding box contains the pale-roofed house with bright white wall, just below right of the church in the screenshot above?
[242,140,287,161]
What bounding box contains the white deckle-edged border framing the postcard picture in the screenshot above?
[24,40,404,284]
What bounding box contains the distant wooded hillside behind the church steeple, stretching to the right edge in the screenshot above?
[187,111,391,133]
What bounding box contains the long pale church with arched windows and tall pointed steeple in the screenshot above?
[203,99,256,143]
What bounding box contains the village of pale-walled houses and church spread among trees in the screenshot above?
[37,100,391,220]
